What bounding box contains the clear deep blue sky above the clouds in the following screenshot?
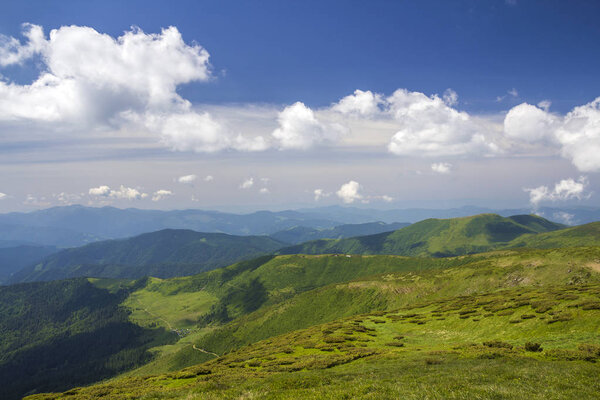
[0,0,600,112]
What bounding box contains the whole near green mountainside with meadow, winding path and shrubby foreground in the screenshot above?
[22,247,600,400]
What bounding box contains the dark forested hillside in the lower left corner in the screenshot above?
[0,279,176,399]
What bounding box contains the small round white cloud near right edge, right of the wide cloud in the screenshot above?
[504,103,556,142]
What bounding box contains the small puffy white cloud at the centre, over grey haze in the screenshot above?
[272,102,344,150]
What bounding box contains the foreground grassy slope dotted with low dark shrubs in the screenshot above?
[32,277,600,399]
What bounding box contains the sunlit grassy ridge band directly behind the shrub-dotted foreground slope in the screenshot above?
[134,248,600,374]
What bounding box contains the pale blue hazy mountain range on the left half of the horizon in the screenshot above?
[0,205,340,247]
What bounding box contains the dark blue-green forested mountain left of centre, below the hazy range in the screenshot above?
[9,229,283,283]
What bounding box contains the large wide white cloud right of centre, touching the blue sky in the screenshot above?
[387,89,498,157]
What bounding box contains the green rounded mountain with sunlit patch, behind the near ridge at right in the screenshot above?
[279,214,565,257]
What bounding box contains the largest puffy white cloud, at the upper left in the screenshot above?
[0,25,211,126]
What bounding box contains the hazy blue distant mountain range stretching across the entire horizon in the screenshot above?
[0,205,600,248]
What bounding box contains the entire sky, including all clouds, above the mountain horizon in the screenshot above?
[0,0,600,216]
